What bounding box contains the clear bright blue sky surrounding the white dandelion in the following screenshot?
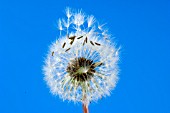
[0,0,170,113]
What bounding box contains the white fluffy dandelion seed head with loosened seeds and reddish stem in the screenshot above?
[43,8,119,113]
